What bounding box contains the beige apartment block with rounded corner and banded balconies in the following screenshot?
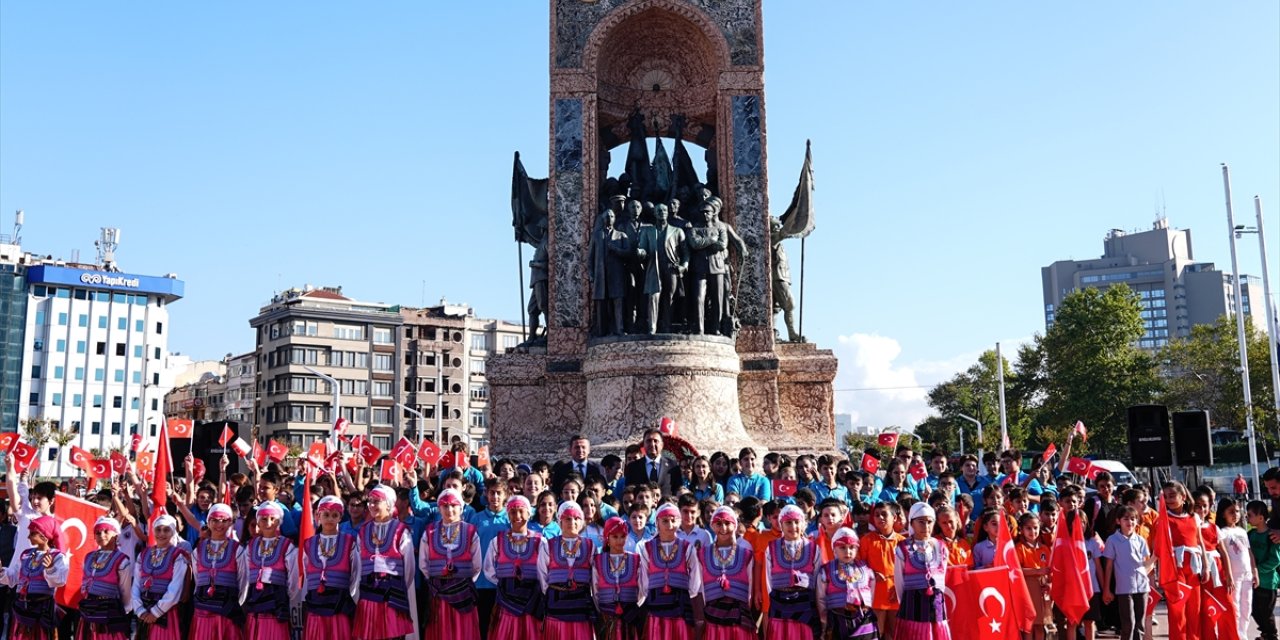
[250,287,403,451]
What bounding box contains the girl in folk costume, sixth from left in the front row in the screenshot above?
[300,495,360,640]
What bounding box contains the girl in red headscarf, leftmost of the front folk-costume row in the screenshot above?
[3,516,70,640]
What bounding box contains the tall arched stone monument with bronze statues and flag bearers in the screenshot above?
[486,0,836,458]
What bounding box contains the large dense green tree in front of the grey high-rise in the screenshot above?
[1025,284,1161,457]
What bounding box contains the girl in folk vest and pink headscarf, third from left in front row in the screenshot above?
[129,515,191,640]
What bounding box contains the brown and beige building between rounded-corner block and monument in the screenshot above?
[401,300,524,442]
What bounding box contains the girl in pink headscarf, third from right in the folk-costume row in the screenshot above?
[764,504,822,640]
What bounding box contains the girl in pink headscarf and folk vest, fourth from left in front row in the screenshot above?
[191,503,244,640]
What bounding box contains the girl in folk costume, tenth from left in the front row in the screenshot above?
[538,502,595,640]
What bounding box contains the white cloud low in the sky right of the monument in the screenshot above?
[835,333,1030,429]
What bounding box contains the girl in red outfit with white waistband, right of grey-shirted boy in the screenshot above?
[1155,481,1210,640]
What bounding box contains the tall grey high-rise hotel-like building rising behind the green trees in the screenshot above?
[1041,218,1266,349]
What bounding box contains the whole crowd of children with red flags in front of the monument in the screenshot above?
[0,433,1280,640]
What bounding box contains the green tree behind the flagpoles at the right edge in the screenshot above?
[1158,315,1276,439]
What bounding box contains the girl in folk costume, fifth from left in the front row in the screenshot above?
[239,502,301,640]
